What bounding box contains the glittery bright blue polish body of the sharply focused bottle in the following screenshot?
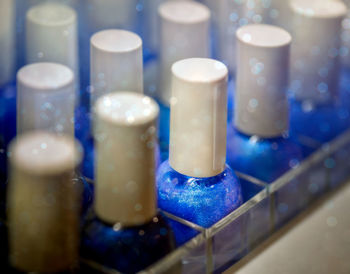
[157,161,242,229]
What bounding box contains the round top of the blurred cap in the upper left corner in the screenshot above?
[27,3,76,26]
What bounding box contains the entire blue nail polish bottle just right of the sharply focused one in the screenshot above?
[227,24,302,183]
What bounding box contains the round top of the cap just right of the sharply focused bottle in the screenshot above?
[236,24,292,48]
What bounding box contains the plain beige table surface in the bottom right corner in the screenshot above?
[225,182,350,274]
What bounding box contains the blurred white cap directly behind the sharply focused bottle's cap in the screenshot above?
[158,1,210,104]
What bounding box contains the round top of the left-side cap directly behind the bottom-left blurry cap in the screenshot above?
[17,63,74,90]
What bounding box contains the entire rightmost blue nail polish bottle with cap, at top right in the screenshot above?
[290,0,350,142]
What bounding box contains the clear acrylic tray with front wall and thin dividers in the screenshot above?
[83,129,350,274]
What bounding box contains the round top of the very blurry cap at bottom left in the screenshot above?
[10,131,82,175]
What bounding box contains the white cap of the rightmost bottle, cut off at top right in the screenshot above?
[290,0,347,104]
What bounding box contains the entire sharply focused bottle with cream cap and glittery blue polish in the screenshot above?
[157,58,242,237]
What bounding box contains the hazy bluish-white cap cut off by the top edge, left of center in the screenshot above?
[84,0,138,32]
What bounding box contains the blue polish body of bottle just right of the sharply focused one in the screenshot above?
[227,124,303,183]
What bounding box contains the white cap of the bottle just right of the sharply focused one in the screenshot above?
[234,24,292,137]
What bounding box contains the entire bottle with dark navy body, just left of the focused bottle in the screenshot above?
[81,92,174,273]
